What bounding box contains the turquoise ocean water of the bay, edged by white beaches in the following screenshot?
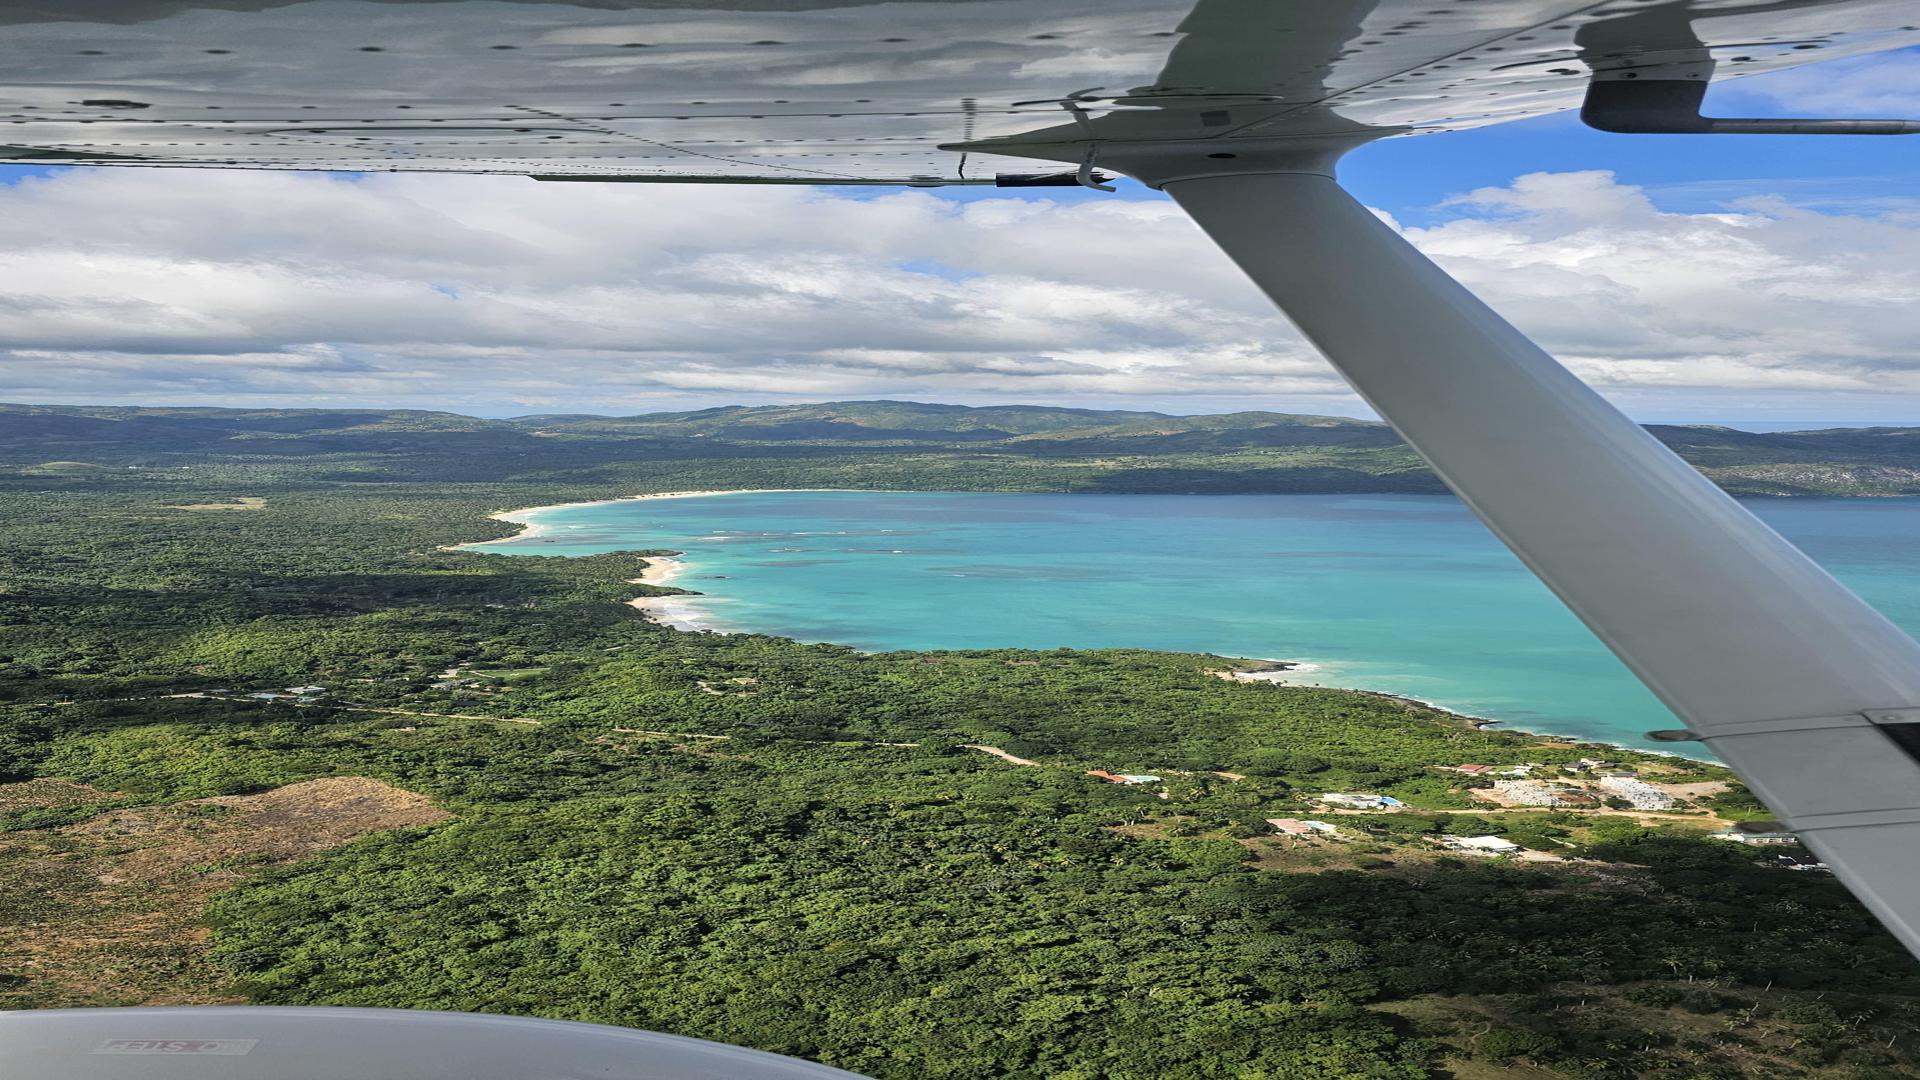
[478,492,1920,746]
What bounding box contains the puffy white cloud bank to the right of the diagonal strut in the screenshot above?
[1409,173,1920,394]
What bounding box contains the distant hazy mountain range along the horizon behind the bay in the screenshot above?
[0,402,1920,494]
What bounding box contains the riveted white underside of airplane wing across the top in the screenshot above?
[0,0,1920,184]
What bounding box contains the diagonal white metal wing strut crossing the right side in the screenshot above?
[1108,152,1920,953]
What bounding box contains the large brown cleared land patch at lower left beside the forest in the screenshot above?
[0,776,449,1009]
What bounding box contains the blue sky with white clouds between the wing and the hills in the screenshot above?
[0,50,1920,427]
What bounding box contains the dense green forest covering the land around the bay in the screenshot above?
[0,405,1920,1080]
